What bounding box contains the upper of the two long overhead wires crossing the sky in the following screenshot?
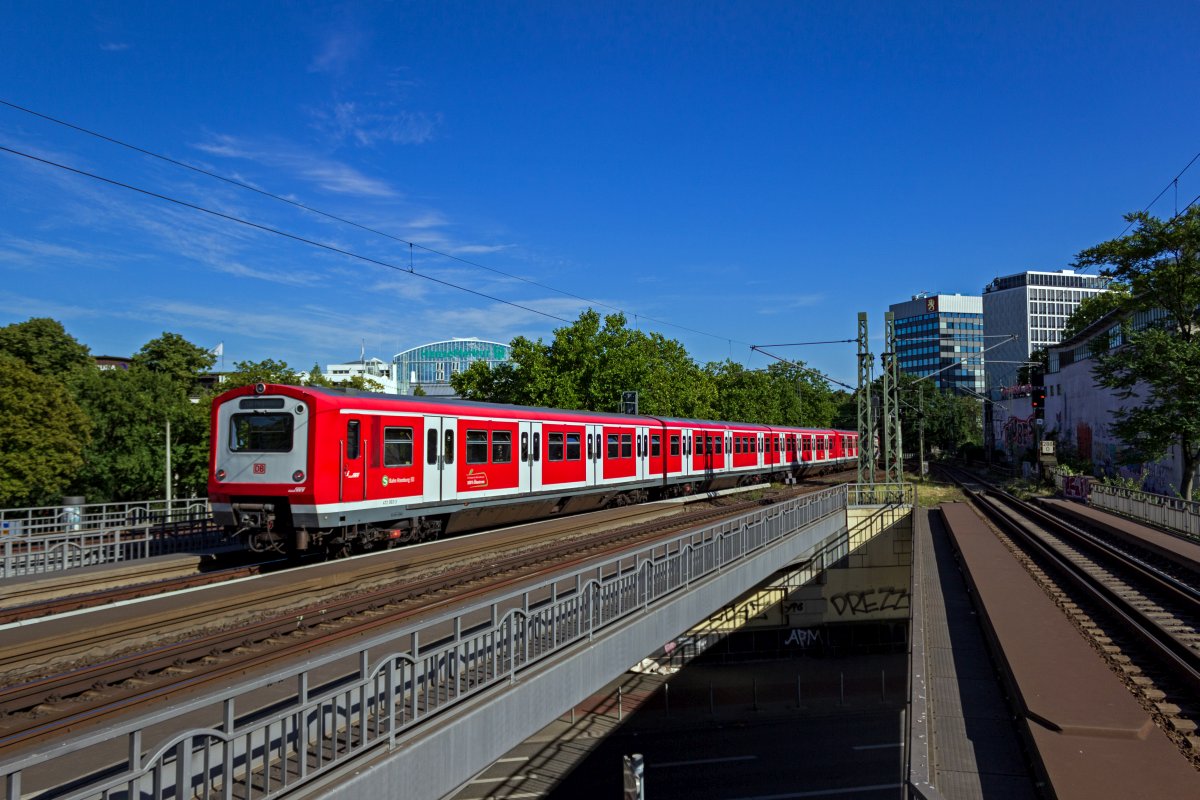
[0,98,750,357]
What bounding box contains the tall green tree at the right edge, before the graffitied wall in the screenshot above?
[1074,207,1200,498]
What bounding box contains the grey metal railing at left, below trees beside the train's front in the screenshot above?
[0,498,222,578]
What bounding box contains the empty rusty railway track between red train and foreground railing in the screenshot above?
[0,489,803,753]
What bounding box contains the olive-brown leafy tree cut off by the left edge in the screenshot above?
[0,354,91,507]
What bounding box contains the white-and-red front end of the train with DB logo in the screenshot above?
[209,384,316,553]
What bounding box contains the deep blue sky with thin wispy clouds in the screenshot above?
[0,0,1200,383]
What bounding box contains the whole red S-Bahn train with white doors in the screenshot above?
[209,384,858,554]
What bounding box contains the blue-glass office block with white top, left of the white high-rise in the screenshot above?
[888,294,984,395]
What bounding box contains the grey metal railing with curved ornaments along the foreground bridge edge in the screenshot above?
[0,486,892,800]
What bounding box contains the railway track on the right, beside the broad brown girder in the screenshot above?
[936,462,1200,768]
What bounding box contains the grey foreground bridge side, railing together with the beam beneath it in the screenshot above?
[0,486,864,800]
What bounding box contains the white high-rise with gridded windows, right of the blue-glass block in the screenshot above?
[983,270,1109,392]
